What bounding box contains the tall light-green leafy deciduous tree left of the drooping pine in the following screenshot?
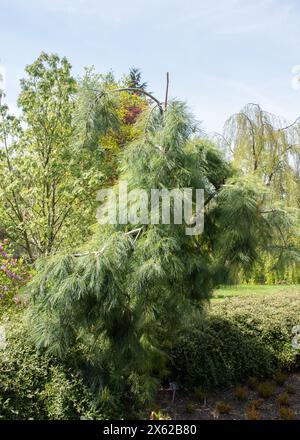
[0,53,103,260]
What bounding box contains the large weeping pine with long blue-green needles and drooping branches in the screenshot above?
[30,83,296,410]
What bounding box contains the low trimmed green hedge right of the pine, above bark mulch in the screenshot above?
[170,294,300,388]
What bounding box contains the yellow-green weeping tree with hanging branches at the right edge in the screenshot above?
[222,104,300,281]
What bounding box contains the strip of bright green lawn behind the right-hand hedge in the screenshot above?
[212,284,300,301]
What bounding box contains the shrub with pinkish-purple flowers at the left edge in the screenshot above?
[0,239,31,307]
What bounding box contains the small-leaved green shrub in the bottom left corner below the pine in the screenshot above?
[0,311,122,420]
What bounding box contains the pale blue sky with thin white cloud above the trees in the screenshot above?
[0,0,300,132]
